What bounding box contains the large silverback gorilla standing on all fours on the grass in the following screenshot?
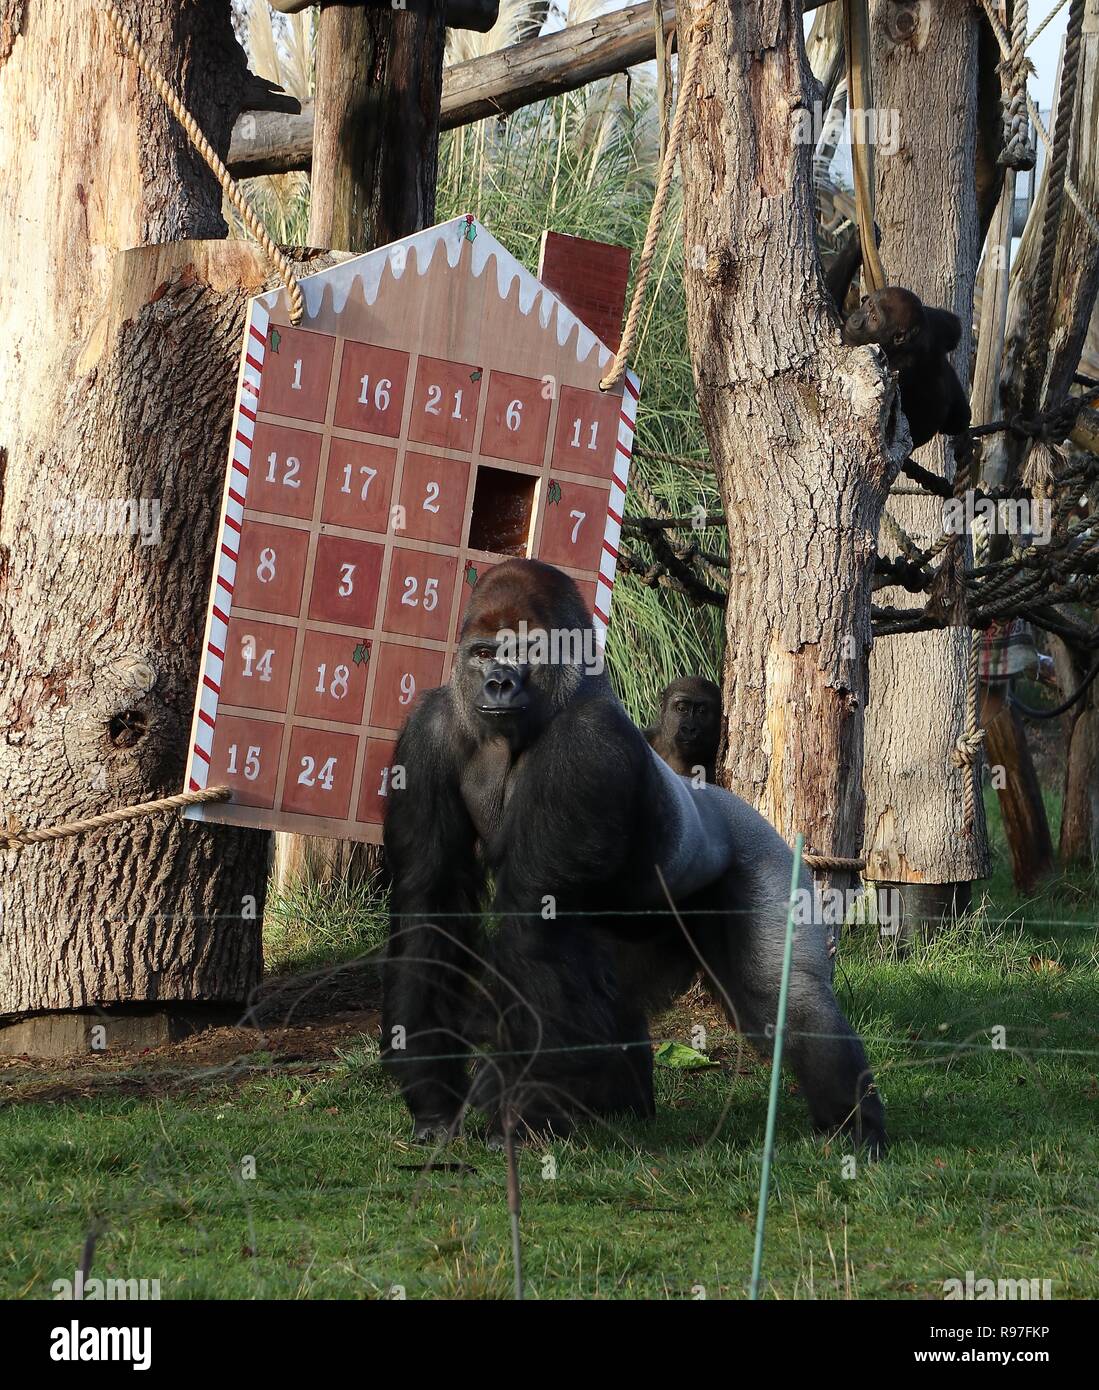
[382,560,885,1152]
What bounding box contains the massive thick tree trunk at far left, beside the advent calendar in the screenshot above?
[0,0,268,1049]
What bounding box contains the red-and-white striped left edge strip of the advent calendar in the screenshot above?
[186,299,271,791]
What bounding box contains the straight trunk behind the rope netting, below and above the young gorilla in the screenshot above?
[866,0,989,902]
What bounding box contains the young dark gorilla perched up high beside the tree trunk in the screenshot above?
[843,286,970,449]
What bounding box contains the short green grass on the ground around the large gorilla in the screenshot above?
[0,795,1099,1298]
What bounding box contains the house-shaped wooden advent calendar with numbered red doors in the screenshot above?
[186,217,638,842]
